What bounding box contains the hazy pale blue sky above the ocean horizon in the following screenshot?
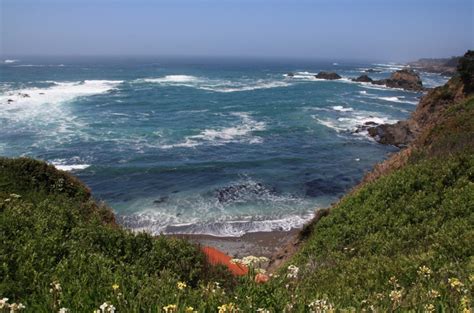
[0,0,474,61]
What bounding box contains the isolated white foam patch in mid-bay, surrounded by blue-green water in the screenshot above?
[161,112,266,149]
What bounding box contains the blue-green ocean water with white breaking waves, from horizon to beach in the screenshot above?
[0,57,446,236]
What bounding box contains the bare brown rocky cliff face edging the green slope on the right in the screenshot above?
[368,51,474,147]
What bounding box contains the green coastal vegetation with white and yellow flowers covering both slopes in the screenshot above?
[0,53,474,312]
